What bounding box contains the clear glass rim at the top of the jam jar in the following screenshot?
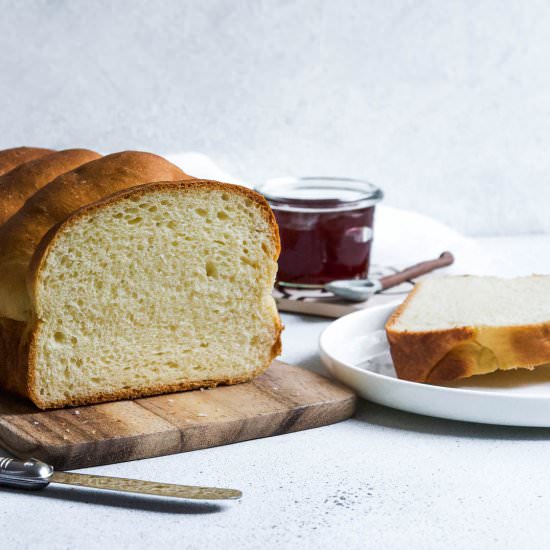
[254,176,384,213]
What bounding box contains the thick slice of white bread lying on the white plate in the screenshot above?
[386,275,550,383]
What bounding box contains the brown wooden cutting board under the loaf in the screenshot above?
[0,361,357,469]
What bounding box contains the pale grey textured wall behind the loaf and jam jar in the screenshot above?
[0,0,550,235]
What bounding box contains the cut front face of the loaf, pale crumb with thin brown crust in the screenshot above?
[10,180,281,408]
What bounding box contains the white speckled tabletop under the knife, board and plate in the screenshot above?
[0,235,550,550]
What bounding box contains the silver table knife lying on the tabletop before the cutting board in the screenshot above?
[0,457,242,500]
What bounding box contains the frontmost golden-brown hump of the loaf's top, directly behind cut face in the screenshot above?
[0,151,191,321]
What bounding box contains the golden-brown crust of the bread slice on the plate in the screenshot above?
[386,283,550,383]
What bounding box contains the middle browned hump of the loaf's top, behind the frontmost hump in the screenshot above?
[0,149,101,225]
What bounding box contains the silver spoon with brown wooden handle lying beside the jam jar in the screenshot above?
[277,251,454,302]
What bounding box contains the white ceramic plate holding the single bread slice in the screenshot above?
[319,303,550,427]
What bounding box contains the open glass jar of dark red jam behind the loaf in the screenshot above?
[257,177,383,285]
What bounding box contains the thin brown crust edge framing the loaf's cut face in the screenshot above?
[8,180,283,409]
